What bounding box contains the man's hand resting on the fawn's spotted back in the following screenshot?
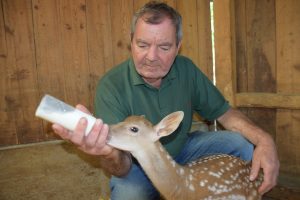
[250,138,279,194]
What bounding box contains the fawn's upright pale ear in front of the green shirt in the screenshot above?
[154,111,184,140]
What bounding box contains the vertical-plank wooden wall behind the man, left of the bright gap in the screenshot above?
[0,0,212,146]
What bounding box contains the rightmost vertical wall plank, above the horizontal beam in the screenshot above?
[276,0,300,93]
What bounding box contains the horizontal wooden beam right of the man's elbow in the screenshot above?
[235,93,300,109]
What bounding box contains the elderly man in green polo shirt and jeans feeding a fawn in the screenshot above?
[53,2,279,200]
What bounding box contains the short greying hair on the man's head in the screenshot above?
[131,1,182,46]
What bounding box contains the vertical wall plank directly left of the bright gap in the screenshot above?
[197,0,213,80]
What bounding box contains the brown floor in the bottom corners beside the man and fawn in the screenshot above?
[0,141,300,200]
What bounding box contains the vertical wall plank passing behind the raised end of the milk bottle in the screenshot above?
[32,0,65,140]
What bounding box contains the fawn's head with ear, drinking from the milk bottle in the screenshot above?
[108,111,184,151]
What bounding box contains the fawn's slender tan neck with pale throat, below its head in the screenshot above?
[132,142,193,199]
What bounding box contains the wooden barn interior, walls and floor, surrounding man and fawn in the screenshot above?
[0,0,300,200]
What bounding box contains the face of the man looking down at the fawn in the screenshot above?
[131,18,180,87]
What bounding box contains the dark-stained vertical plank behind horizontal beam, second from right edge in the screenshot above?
[241,0,276,141]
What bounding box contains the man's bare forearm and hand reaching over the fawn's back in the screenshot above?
[218,108,279,194]
